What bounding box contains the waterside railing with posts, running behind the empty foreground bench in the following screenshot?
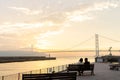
[0,64,68,80]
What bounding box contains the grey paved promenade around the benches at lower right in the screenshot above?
[77,63,120,80]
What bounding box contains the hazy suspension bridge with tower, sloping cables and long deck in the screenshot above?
[47,34,120,56]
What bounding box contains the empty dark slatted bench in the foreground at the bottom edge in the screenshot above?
[22,72,77,80]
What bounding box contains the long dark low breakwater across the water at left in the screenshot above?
[0,56,56,63]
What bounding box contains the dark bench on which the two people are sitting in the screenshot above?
[67,64,94,75]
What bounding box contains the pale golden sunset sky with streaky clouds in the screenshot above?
[0,0,120,51]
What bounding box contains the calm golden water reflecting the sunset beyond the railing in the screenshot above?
[0,52,119,75]
